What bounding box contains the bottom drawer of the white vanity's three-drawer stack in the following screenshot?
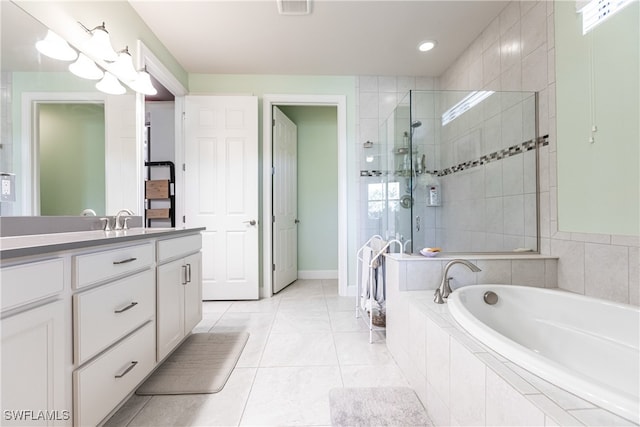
[73,322,155,426]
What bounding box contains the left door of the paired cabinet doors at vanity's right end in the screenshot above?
[156,259,186,361]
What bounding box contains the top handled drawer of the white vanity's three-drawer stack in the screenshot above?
[73,242,153,289]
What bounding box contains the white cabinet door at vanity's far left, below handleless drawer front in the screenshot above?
[0,301,71,426]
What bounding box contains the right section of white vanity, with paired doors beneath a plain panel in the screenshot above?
[157,234,202,361]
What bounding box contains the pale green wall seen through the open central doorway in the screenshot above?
[279,106,338,271]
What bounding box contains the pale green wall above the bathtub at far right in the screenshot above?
[555,1,640,235]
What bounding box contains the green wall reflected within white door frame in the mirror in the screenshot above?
[38,103,105,215]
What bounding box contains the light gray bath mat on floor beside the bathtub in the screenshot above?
[329,387,433,427]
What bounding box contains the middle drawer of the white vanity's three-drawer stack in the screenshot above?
[73,270,156,365]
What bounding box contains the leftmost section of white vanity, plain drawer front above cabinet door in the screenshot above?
[0,257,71,426]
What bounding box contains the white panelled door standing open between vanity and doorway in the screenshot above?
[185,96,259,300]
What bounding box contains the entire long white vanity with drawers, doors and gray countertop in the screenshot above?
[0,229,202,426]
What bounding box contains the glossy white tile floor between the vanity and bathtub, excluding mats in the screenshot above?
[105,280,408,427]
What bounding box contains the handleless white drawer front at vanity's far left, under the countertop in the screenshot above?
[0,258,64,310]
